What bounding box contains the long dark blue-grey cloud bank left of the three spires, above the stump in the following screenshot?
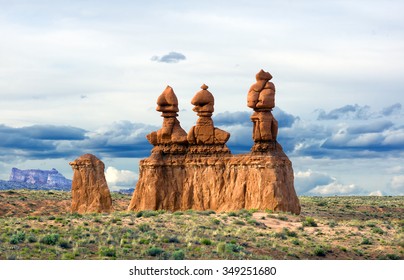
[0,121,158,160]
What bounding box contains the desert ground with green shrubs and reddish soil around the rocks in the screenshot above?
[0,190,404,260]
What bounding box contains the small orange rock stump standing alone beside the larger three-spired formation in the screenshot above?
[69,154,112,214]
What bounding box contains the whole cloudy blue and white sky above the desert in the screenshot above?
[0,0,404,195]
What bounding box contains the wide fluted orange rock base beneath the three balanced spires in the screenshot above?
[128,143,300,214]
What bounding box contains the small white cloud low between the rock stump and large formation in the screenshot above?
[105,166,138,190]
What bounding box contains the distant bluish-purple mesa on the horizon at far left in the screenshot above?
[0,167,72,191]
